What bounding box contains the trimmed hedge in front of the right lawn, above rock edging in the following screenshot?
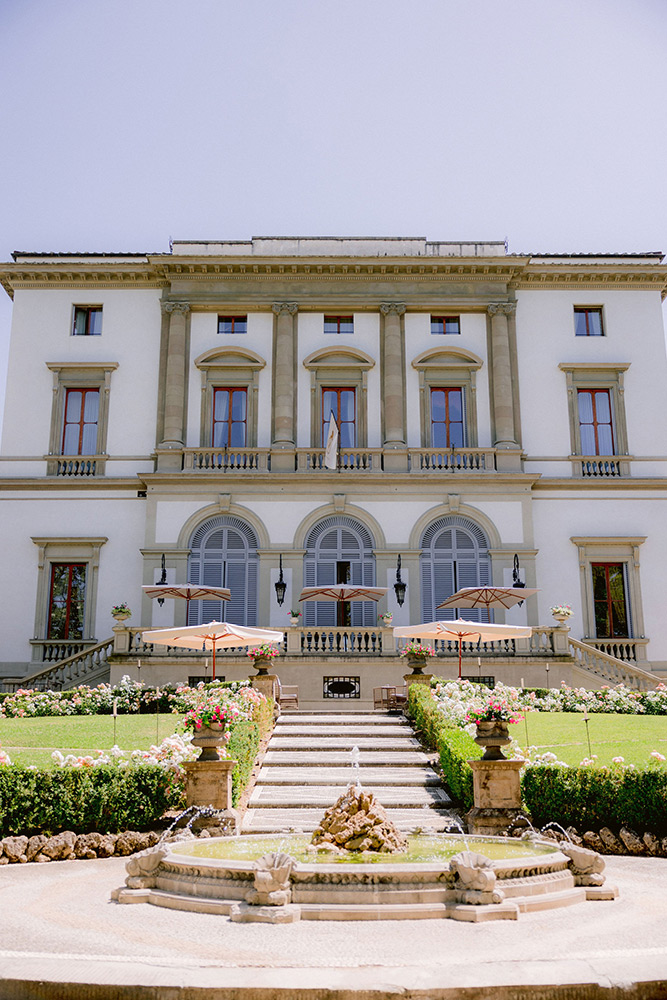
[522,764,667,836]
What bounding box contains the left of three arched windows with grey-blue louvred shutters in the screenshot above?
[188,516,258,625]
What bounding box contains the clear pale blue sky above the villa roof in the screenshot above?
[0,0,667,426]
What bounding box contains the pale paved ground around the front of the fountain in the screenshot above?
[0,858,667,1000]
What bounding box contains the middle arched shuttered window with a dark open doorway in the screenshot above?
[302,516,377,626]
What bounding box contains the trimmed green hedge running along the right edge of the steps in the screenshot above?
[408,684,482,809]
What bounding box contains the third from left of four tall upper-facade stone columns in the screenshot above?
[380,302,408,472]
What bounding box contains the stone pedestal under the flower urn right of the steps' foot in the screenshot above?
[466,760,524,836]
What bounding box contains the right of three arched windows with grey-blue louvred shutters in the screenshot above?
[421,515,491,622]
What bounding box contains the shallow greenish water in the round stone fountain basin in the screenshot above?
[171,833,558,865]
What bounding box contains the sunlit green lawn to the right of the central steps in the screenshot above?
[510,712,667,767]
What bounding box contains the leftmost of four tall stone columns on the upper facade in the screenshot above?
[158,302,190,471]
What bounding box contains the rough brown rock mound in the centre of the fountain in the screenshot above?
[312,785,408,854]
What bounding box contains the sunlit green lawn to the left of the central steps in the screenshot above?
[0,714,182,767]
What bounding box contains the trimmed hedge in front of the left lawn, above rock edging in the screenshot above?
[0,764,180,837]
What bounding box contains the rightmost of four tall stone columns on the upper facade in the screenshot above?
[488,302,521,471]
